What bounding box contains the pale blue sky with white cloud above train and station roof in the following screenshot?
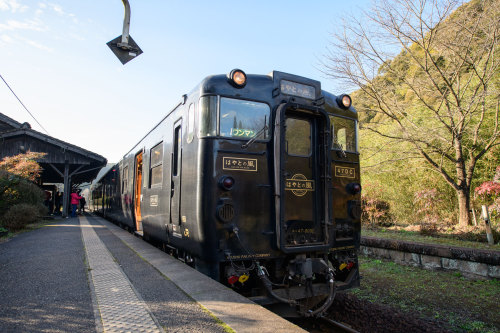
[0,0,369,163]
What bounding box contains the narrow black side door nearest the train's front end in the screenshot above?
[170,120,182,237]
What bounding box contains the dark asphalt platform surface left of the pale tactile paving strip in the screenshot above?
[0,219,96,333]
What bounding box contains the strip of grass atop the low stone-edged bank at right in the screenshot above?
[361,229,500,251]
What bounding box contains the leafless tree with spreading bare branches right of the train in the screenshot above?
[323,0,500,225]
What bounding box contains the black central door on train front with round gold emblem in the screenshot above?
[275,104,329,252]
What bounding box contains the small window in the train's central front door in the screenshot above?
[285,118,312,156]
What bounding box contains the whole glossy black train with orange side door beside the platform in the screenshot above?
[92,69,361,316]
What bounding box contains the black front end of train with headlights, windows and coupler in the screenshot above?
[200,70,361,316]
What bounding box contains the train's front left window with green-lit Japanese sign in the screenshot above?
[220,98,271,140]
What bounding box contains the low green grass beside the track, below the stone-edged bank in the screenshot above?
[351,257,500,332]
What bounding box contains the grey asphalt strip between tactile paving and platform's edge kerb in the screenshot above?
[88,217,229,333]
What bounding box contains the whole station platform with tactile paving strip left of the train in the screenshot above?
[0,214,305,333]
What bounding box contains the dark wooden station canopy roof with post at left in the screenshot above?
[0,113,107,215]
